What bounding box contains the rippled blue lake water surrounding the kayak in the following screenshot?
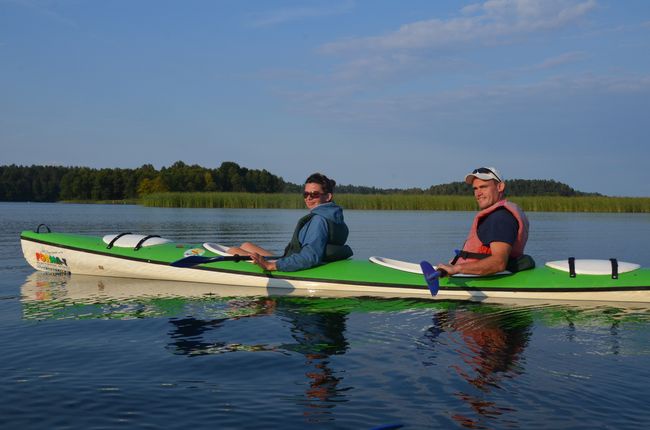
[0,203,650,429]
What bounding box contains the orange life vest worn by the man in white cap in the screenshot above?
[452,200,529,264]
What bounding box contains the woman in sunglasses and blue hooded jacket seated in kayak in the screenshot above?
[228,173,352,272]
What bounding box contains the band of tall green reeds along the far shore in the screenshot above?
[141,192,650,213]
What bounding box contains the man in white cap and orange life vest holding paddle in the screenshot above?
[438,167,534,276]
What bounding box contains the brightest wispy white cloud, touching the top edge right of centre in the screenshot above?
[310,0,597,90]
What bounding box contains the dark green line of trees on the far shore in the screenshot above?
[0,161,599,202]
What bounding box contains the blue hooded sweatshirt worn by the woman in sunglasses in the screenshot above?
[275,202,344,272]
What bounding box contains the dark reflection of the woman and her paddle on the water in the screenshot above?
[168,297,349,414]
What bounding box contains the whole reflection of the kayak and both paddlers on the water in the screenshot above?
[21,273,650,428]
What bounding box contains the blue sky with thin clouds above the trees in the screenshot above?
[0,0,650,196]
